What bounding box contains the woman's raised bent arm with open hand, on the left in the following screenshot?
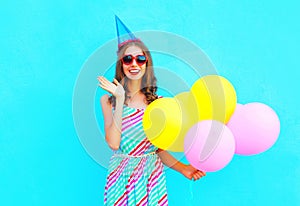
[98,77,125,150]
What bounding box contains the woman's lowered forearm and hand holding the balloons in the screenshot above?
[157,149,206,180]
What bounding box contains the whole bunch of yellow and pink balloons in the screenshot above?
[143,75,280,172]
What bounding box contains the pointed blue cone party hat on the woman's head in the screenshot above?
[115,15,141,48]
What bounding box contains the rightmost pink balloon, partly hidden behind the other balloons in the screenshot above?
[227,102,280,155]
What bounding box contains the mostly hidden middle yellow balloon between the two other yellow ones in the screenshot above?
[170,92,199,152]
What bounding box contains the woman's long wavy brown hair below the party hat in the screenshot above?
[109,41,158,106]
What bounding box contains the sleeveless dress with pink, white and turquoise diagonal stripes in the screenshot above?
[104,105,168,206]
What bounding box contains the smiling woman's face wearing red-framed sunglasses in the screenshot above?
[122,46,146,80]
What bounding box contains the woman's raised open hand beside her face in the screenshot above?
[98,76,125,99]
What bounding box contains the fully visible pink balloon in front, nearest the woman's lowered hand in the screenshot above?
[184,120,235,172]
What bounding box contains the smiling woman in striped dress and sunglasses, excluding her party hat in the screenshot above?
[98,40,205,205]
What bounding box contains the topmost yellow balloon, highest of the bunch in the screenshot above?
[191,75,237,123]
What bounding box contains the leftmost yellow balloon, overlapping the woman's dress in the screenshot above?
[142,97,182,151]
